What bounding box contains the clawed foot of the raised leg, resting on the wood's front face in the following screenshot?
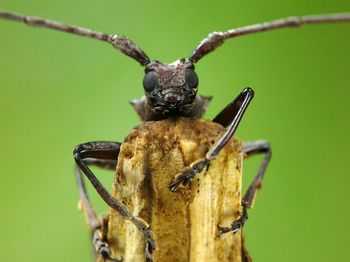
[168,158,210,192]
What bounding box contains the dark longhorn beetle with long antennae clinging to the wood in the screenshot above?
[0,11,350,261]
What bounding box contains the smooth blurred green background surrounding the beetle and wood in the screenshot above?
[0,0,350,262]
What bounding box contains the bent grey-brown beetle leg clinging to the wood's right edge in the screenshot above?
[219,140,271,234]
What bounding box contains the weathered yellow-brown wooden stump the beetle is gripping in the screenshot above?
[102,118,243,262]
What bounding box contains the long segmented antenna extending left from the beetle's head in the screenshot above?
[0,10,150,66]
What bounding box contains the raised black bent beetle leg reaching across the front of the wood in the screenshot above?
[169,88,254,192]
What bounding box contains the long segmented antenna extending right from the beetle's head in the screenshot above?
[189,13,350,63]
